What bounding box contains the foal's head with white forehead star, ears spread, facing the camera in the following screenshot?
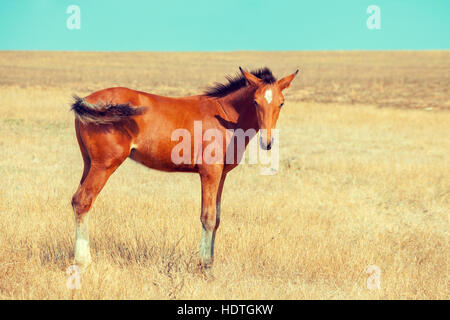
[239,68,298,150]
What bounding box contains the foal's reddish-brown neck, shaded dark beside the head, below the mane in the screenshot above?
[218,86,259,131]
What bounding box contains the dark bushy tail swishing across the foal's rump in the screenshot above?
[71,96,144,124]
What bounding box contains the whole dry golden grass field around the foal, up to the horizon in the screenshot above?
[0,51,450,299]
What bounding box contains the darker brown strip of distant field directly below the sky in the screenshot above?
[0,51,450,109]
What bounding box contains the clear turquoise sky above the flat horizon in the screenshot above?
[0,0,450,51]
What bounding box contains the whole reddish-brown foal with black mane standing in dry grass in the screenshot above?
[72,68,298,269]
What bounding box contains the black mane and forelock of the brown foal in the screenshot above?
[204,67,277,98]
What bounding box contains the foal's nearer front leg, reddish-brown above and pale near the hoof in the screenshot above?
[200,169,222,268]
